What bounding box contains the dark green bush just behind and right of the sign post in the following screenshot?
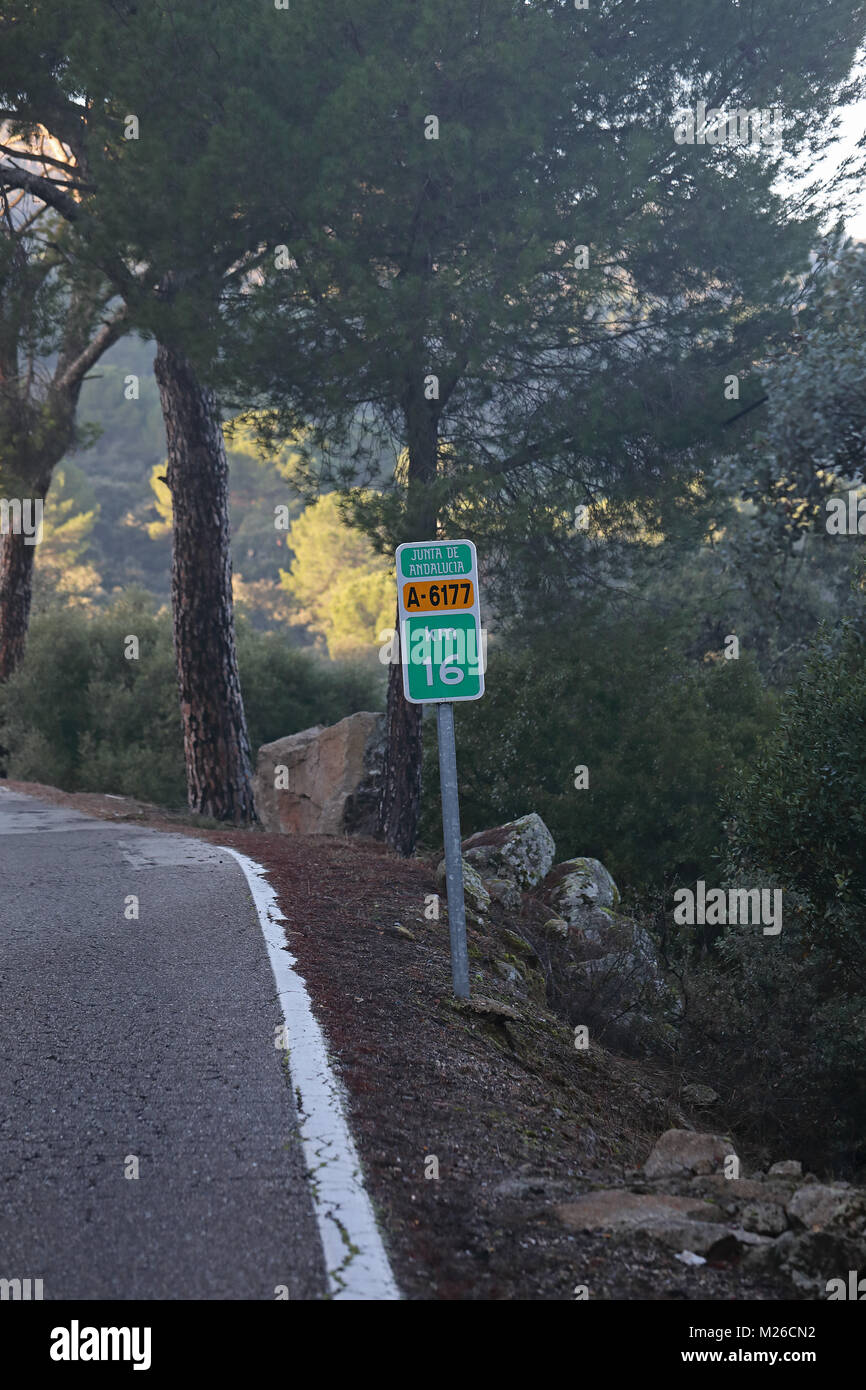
[423,613,774,892]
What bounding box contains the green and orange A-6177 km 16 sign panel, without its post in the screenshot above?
[396,541,484,705]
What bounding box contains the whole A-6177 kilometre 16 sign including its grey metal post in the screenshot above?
[396,541,484,999]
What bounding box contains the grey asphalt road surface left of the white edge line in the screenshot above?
[0,791,325,1300]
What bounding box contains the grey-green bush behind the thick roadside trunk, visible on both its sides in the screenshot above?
[0,594,382,805]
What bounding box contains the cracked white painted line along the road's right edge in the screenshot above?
[220,845,400,1301]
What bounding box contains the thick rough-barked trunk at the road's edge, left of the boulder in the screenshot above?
[154,343,256,824]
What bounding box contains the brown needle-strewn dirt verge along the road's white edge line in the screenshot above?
[4,781,791,1301]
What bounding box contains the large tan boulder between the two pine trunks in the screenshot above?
[253,712,385,835]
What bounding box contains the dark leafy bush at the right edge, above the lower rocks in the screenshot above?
[684,621,866,1170]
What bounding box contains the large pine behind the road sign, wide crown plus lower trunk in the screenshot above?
[221,0,866,853]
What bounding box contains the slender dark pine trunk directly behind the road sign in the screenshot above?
[378,383,439,856]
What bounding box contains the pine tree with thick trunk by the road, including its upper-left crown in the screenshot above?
[0,0,273,823]
